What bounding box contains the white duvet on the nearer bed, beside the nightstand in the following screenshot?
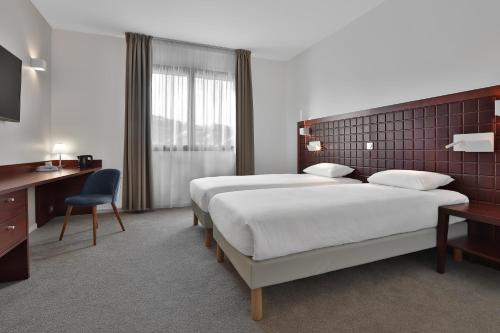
[209,184,469,260]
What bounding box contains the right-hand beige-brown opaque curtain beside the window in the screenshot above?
[235,50,255,176]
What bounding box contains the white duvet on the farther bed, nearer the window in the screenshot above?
[189,174,361,212]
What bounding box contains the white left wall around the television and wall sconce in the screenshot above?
[0,0,51,165]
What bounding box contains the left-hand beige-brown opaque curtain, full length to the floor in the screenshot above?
[122,33,152,211]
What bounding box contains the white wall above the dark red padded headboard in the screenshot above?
[287,0,500,170]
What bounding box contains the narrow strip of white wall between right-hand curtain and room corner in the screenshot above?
[252,58,289,174]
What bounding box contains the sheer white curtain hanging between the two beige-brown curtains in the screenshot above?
[151,39,236,208]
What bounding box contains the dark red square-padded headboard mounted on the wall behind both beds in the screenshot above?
[297,86,500,204]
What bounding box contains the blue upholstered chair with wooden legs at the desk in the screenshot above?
[59,169,125,246]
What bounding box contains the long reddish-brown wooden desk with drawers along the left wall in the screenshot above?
[0,160,102,282]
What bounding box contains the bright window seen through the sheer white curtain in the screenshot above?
[151,66,236,151]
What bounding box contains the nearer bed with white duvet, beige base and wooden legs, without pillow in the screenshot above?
[209,184,468,320]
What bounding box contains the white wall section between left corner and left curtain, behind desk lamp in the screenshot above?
[52,30,126,204]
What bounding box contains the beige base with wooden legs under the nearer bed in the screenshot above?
[213,222,467,320]
